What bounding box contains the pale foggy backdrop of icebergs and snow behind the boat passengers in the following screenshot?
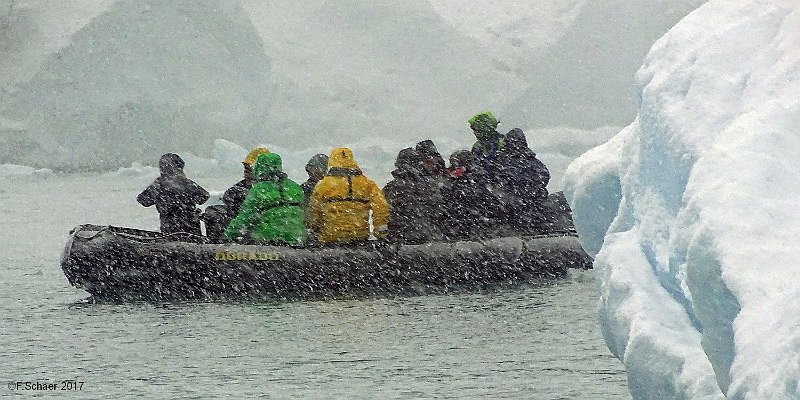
[0,0,703,187]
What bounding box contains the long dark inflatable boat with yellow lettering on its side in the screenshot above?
[61,225,592,301]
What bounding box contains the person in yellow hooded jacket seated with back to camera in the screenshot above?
[308,147,389,243]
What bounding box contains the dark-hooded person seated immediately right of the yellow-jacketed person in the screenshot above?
[383,148,444,244]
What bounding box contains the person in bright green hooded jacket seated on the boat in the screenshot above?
[223,153,307,244]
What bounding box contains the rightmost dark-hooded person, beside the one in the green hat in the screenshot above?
[499,128,550,233]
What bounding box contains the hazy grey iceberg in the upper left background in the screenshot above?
[0,0,273,171]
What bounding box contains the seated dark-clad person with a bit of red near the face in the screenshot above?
[442,150,503,240]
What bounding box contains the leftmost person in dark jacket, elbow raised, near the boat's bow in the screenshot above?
[136,153,208,235]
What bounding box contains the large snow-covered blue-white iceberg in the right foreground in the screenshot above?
[564,0,800,399]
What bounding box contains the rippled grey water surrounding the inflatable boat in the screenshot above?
[0,174,631,399]
